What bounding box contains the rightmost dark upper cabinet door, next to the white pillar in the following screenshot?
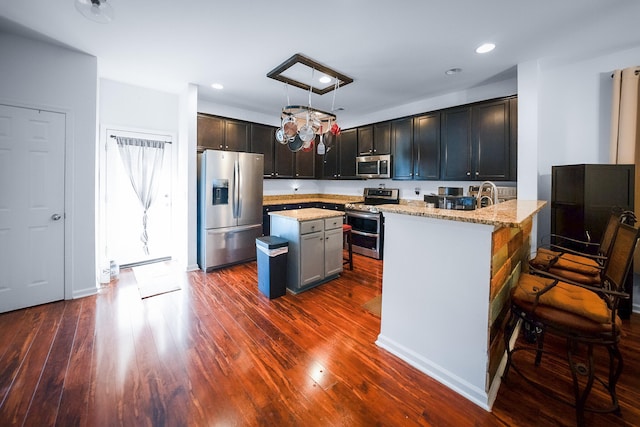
[472,100,510,180]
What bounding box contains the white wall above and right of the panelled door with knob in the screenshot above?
[0,33,97,299]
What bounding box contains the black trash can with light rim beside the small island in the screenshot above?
[256,236,289,299]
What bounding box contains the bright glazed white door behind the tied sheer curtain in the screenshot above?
[105,132,173,265]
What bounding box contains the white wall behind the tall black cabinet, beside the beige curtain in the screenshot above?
[532,46,640,244]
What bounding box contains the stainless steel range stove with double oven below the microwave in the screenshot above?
[345,188,400,259]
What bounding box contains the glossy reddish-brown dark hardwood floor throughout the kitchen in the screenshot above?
[0,255,640,426]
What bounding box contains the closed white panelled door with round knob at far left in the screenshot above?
[0,104,65,312]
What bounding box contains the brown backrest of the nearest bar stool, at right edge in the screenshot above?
[602,224,640,292]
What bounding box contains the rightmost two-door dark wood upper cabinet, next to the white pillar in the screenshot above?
[440,98,517,181]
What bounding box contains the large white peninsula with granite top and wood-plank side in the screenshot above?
[376,200,546,410]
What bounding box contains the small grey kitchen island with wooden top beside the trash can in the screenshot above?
[269,208,343,294]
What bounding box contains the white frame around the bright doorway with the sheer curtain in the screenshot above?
[96,124,178,274]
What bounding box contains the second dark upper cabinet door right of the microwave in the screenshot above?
[413,113,440,179]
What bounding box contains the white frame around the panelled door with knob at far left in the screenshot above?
[0,98,75,300]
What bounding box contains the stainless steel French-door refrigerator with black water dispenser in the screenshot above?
[198,150,264,271]
